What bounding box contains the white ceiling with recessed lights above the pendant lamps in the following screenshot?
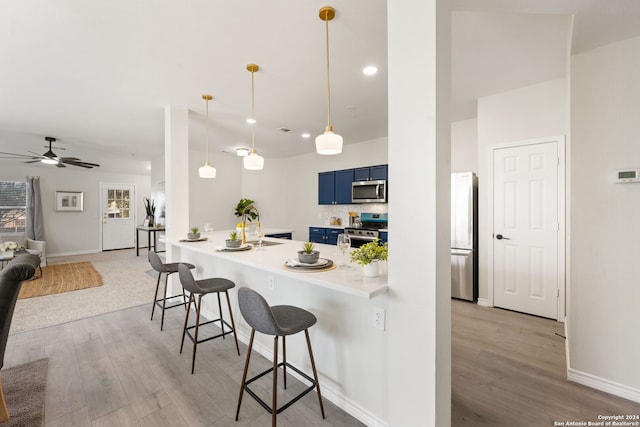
[0,0,640,173]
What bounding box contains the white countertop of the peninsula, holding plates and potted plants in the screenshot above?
[170,229,388,299]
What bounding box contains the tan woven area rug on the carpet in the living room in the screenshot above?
[18,261,102,299]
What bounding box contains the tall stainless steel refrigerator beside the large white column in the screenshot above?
[451,172,478,301]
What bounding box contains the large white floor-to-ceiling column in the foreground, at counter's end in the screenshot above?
[387,0,451,427]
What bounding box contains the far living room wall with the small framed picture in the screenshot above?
[0,164,150,257]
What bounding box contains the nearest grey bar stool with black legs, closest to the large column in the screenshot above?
[236,288,325,427]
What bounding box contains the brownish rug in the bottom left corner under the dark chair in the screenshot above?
[0,359,49,427]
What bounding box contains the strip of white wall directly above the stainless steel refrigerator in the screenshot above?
[451,118,478,174]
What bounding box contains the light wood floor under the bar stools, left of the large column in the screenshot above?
[4,304,363,427]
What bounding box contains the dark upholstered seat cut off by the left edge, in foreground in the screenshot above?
[0,254,40,423]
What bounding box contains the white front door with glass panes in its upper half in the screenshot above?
[101,184,136,251]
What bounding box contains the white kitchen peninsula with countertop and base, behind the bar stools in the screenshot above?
[167,231,388,426]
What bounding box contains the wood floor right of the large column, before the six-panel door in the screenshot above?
[451,300,640,427]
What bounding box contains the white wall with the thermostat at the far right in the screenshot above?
[568,38,640,394]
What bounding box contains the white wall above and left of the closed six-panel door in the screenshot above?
[478,79,568,300]
